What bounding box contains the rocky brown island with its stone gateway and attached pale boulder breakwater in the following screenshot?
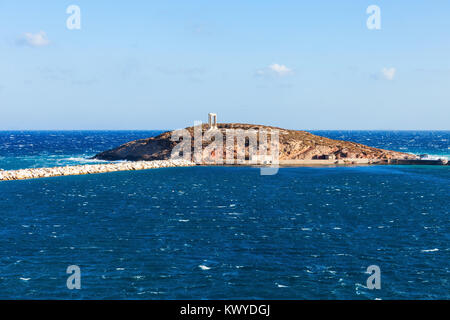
[0,118,448,181]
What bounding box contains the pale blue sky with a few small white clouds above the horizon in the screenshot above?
[0,0,450,130]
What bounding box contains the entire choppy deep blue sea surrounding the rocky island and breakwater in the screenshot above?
[0,131,450,300]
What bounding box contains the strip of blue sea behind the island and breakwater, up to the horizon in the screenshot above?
[0,130,450,170]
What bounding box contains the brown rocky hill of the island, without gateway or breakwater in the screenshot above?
[94,123,418,164]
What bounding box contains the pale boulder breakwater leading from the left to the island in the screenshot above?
[0,159,195,181]
